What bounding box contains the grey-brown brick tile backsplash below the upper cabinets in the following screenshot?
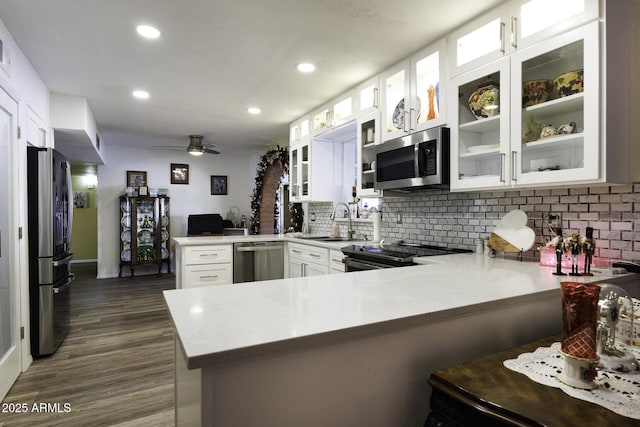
[307,183,640,261]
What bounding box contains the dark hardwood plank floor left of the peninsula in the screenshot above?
[0,264,175,427]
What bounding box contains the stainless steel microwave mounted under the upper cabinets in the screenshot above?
[374,126,449,190]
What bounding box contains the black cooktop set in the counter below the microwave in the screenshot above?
[342,244,471,264]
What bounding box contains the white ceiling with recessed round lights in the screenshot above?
[0,0,502,162]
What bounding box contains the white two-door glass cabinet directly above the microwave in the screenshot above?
[381,40,446,141]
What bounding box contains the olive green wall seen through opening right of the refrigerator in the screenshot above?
[71,174,98,261]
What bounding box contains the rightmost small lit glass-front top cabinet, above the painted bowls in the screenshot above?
[511,0,599,49]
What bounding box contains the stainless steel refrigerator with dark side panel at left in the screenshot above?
[27,147,73,357]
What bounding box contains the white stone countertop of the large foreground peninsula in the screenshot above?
[164,254,630,369]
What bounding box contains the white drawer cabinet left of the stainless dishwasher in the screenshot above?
[176,245,233,289]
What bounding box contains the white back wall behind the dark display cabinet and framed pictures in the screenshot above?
[97,131,264,278]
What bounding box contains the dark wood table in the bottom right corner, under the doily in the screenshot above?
[425,337,640,427]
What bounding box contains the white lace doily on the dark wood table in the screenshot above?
[503,342,640,420]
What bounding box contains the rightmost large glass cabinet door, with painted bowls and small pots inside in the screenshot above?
[511,22,600,184]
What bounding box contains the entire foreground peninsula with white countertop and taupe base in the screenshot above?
[165,254,636,426]
